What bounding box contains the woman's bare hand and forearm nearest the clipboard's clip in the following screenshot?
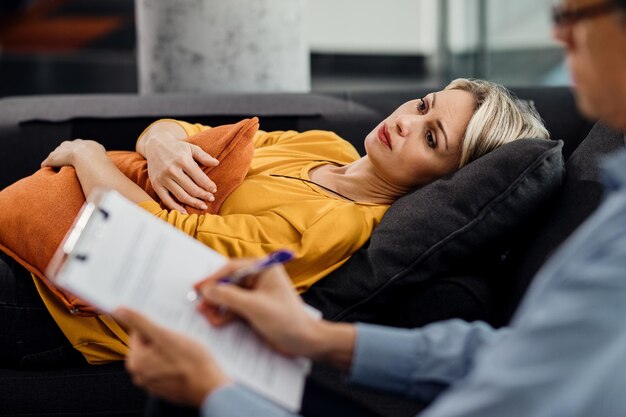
[41,139,152,203]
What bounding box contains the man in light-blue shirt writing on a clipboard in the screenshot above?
[117,0,626,417]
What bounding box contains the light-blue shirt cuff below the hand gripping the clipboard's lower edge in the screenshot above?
[200,384,296,417]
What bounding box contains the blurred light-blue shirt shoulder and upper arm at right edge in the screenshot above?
[420,188,626,417]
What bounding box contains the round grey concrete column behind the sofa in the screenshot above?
[136,0,310,94]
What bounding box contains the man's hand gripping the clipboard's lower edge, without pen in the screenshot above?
[114,309,231,408]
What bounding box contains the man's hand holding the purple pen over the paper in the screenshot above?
[197,261,322,357]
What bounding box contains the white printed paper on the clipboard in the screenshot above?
[53,191,310,412]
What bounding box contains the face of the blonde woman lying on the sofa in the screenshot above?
[365,90,476,188]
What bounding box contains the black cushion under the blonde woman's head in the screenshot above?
[305,139,564,326]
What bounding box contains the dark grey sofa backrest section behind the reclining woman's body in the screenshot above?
[0,94,378,189]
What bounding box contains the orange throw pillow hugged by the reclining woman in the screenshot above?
[0,117,259,315]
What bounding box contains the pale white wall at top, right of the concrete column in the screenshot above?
[304,0,556,55]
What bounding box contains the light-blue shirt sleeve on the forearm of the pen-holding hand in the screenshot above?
[350,320,508,401]
